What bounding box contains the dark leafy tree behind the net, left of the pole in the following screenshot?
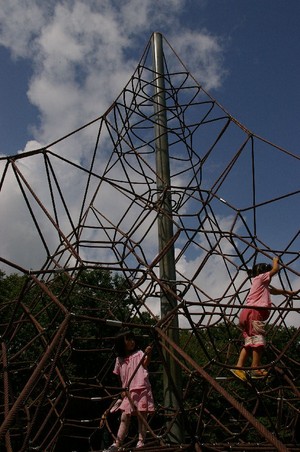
[0,269,152,450]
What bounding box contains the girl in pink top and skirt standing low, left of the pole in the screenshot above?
[104,329,154,452]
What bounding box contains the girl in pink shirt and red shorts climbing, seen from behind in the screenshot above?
[230,257,299,380]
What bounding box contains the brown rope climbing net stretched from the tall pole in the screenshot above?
[0,33,300,452]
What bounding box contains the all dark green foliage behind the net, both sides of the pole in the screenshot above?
[0,269,300,443]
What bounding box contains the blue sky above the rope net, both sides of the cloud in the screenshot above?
[0,0,300,154]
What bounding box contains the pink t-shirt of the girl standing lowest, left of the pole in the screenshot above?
[113,350,150,390]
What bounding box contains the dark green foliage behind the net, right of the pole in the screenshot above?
[180,323,300,444]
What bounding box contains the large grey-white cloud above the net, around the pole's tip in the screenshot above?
[0,0,224,147]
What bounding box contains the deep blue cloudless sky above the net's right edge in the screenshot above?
[186,0,300,153]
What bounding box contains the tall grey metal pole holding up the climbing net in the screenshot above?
[152,33,184,443]
